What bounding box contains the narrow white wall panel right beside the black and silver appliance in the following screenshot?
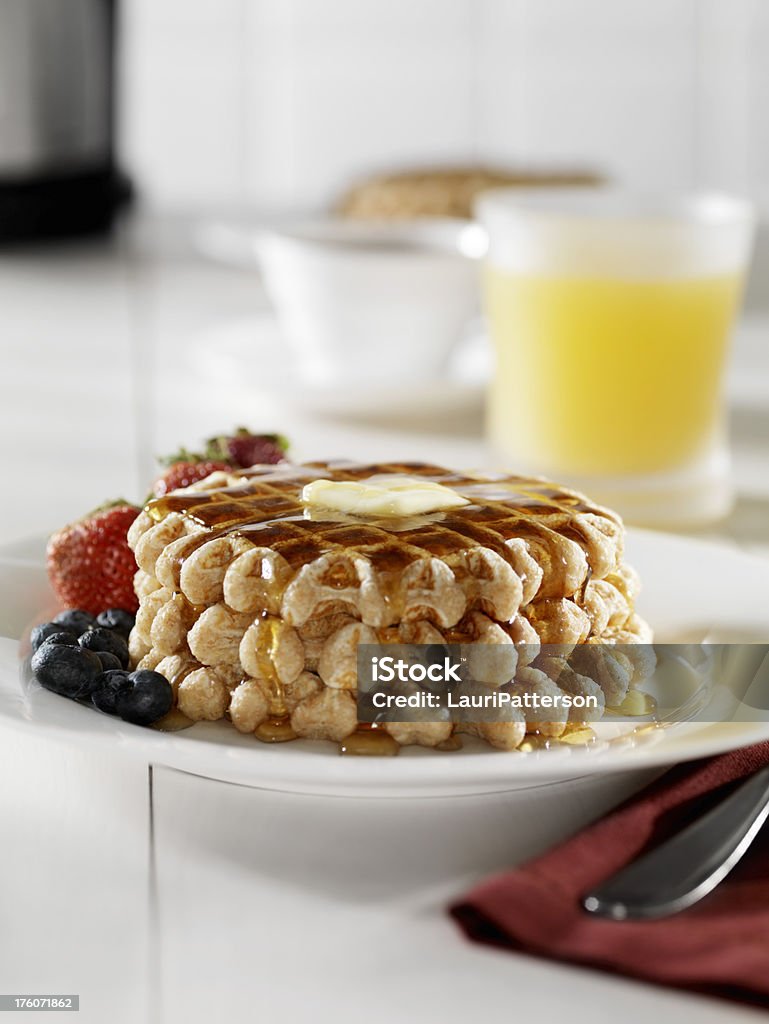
[121,0,245,208]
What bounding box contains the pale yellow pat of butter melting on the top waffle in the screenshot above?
[302,476,470,516]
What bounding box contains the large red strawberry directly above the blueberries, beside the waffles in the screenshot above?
[46,500,139,615]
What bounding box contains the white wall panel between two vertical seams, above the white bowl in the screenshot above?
[243,0,474,206]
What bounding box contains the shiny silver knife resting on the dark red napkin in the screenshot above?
[583,767,769,921]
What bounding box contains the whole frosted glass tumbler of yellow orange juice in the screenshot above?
[476,188,754,525]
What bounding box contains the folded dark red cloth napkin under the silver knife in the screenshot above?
[451,742,769,1007]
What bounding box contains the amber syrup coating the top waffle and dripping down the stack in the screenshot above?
[145,462,618,756]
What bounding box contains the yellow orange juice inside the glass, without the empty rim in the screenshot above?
[484,266,742,475]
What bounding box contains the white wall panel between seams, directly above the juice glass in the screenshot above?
[489,0,695,185]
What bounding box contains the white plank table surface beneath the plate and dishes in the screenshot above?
[0,224,769,1024]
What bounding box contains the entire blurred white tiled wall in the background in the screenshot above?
[121,0,769,210]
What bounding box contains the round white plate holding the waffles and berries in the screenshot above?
[0,530,769,797]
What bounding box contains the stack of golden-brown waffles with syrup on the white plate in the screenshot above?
[129,462,650,750]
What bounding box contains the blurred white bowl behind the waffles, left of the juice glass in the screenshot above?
[257,218,483,383]
